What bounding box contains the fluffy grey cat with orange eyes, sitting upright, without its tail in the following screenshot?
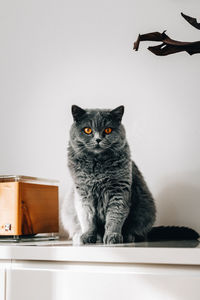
[61,105,199,244]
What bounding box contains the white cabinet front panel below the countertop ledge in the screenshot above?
[6,263,200,300]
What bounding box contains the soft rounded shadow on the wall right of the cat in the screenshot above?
[156,182,200,232]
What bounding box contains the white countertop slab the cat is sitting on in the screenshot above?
[0,242,200,265]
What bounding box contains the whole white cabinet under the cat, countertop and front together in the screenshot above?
[0,241,200,300]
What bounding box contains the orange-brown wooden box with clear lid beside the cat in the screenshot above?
[0,176,58,236]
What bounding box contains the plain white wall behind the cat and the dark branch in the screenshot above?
[0,0,200,230]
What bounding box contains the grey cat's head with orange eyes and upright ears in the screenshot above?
[70,105,125,154]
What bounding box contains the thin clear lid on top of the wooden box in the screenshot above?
[0,175,59,185]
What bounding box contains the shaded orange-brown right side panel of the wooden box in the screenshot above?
[20,183,58,235]
